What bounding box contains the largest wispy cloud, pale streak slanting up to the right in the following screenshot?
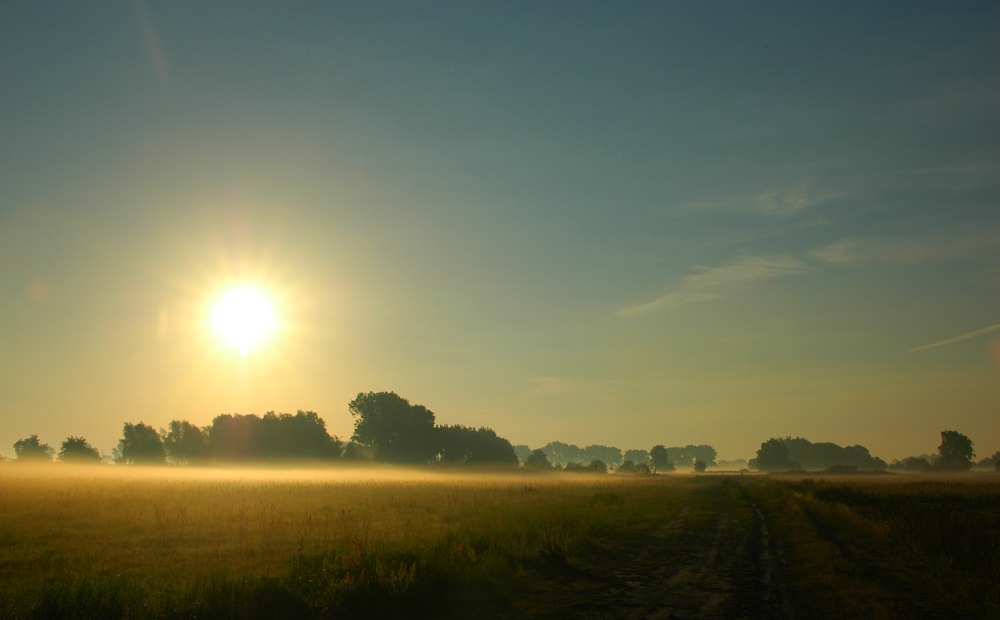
[617,255,806,316]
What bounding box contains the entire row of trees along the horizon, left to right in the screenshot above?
[11,392,988,474]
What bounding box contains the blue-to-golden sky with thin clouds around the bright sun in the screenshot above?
[0,1,1000,461]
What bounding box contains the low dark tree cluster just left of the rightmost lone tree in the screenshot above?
[750,437,887,471]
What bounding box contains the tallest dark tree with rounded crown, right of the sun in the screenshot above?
[347,392,439,463]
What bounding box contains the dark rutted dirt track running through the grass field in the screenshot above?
[594,483,795,620]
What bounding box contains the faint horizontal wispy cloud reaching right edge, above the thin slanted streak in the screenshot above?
[809,234,1000,265]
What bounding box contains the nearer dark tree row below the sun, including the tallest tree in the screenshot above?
[7,392,518,466]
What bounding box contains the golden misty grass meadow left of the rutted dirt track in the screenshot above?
[0,468,687,619]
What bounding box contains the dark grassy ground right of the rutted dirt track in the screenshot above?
[751,476,1000,619]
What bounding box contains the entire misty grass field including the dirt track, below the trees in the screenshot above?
[0,464,1000,620]
